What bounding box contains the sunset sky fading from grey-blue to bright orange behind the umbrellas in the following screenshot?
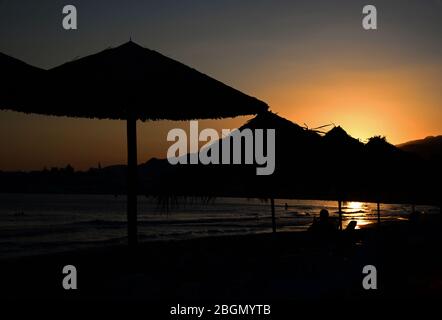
[0,0,442,170]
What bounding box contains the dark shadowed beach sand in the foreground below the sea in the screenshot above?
[0,216,442,303]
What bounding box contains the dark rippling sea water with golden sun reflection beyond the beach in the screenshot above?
[0,194,439,258]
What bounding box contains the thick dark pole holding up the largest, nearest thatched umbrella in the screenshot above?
[127,116,138,247]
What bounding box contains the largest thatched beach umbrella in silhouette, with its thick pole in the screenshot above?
[0,41,268,244]
